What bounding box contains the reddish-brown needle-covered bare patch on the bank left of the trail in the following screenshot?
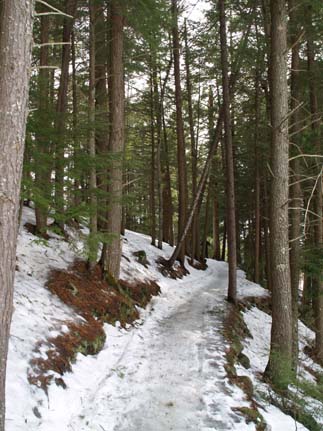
[28,260,160,391]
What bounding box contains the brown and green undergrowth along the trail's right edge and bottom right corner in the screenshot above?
[224,298,323,431]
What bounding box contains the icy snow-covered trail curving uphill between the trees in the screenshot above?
[68,264,255,431]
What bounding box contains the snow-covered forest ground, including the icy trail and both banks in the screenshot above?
[7,209,323,431]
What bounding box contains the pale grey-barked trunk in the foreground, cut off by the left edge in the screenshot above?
[0,0,34,431]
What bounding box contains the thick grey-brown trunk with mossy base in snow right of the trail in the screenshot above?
[266,0,292,387]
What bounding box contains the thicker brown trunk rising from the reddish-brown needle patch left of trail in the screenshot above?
[103,0,124,281]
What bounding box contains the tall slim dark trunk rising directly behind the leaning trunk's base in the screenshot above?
[172,0,187,265]
